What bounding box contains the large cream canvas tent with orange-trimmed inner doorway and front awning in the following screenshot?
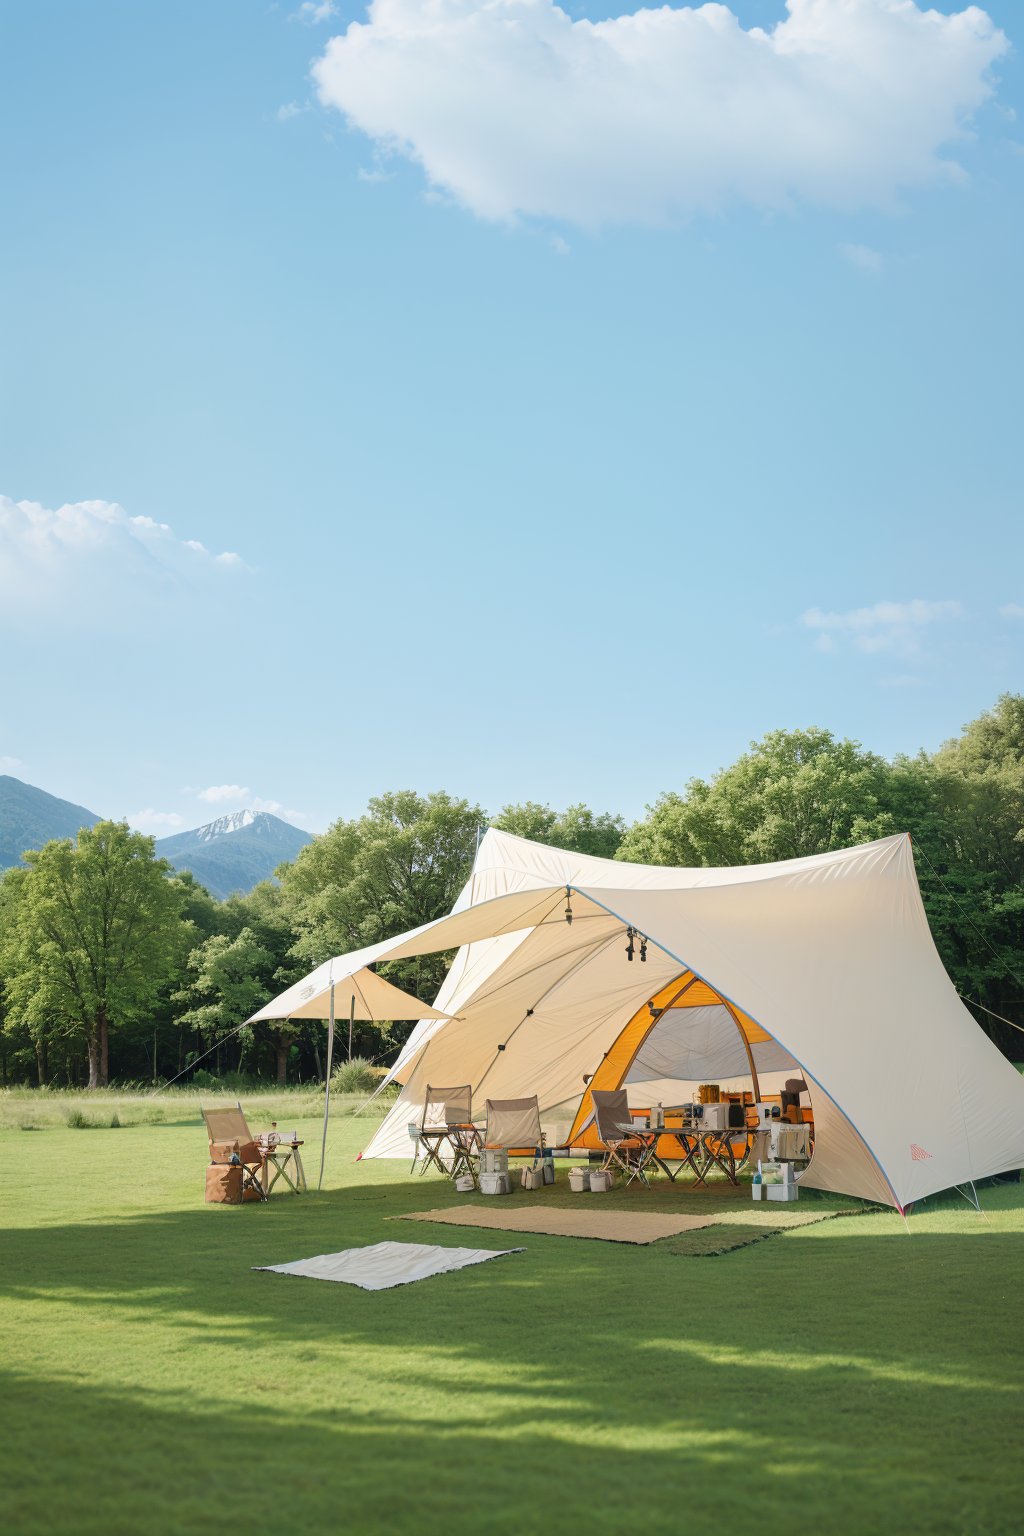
[253,828,1024,1210]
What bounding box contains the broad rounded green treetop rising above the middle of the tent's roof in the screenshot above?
[619,730,889,866]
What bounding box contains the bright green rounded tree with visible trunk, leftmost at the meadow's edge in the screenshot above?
[5,822,192,1087]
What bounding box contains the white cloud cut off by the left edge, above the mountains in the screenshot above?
[0,496,243,605]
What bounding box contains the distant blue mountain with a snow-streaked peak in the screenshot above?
[157,811,313,900]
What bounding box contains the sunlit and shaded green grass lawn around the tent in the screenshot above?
[0,1094,1024,1536]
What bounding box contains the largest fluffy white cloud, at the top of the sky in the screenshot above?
[313,0,1007,226]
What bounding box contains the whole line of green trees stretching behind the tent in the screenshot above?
[0,694,1024,1086]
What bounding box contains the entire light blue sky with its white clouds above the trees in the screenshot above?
[0,0,1024,834]
